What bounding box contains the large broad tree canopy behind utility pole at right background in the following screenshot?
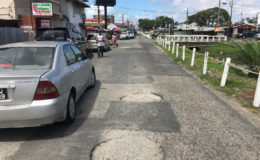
[188,7,230,26]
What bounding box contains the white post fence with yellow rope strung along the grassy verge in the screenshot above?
[157,38,260,108]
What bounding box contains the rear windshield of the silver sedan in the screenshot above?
[0,47,55,70]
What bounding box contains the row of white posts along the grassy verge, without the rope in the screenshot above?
[158,39,260,107]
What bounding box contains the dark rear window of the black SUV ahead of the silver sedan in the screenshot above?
[36,29,68,41]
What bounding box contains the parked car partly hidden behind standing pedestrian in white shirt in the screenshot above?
[87,33,111,51]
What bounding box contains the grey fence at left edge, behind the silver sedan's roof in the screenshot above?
[0,27,29,45]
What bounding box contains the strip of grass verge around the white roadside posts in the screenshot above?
[156,44,260,113]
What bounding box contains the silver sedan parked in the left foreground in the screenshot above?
[0,42,96,128]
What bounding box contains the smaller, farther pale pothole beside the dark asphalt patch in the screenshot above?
[120,93,162,102]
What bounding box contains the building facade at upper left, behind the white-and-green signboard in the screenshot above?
[0,0,89,32]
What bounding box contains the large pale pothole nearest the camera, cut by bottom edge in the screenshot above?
[91,136,163,160]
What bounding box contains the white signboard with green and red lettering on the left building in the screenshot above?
[32,3,53,16]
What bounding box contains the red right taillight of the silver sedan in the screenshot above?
[33,81,60,100]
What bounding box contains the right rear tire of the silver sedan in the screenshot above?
[65,92,76,124]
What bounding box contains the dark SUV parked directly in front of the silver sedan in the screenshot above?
[36,27,88,54]
